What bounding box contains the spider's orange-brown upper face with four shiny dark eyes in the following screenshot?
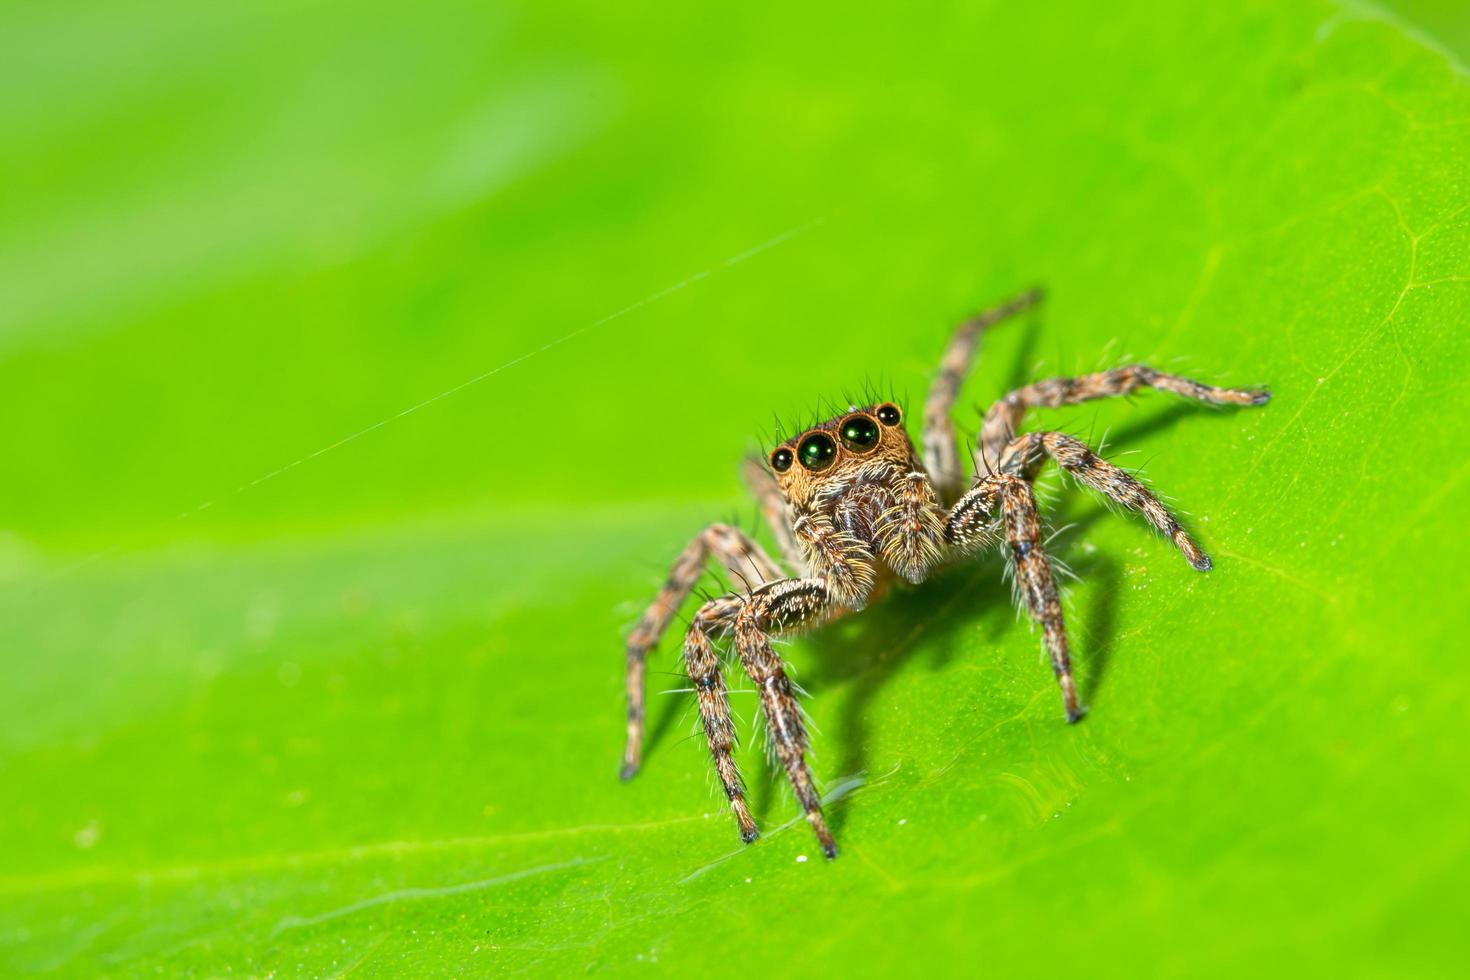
[766,401,916,504]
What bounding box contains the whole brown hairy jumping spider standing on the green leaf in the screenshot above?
[622,289,1270,858]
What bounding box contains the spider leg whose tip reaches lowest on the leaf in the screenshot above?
[735,579,836,858]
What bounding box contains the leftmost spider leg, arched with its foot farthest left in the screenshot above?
[622,525,785,779]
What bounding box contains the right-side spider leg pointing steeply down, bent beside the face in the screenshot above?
[945,473,1082,723]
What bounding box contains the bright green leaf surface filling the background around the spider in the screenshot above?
[0,0,1470,976]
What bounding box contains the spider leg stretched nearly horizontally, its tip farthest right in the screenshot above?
[979,364,1272,464]
